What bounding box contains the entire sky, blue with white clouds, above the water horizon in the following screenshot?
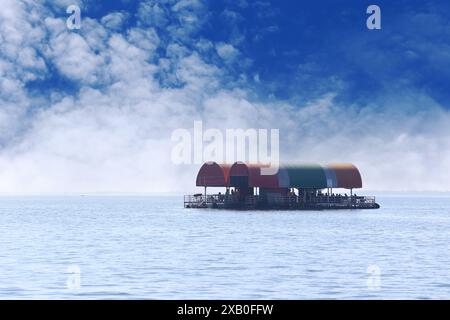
[0,0,450,193]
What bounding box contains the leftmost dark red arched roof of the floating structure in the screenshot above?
[196,161,230,187]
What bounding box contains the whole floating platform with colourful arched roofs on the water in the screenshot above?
[184,162,380,210]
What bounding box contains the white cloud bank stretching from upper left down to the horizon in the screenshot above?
[0,0,450,193]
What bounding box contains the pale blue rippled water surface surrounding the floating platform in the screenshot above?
[0,195,450,299]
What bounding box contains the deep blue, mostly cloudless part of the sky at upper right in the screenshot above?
[37,0,450,104]
